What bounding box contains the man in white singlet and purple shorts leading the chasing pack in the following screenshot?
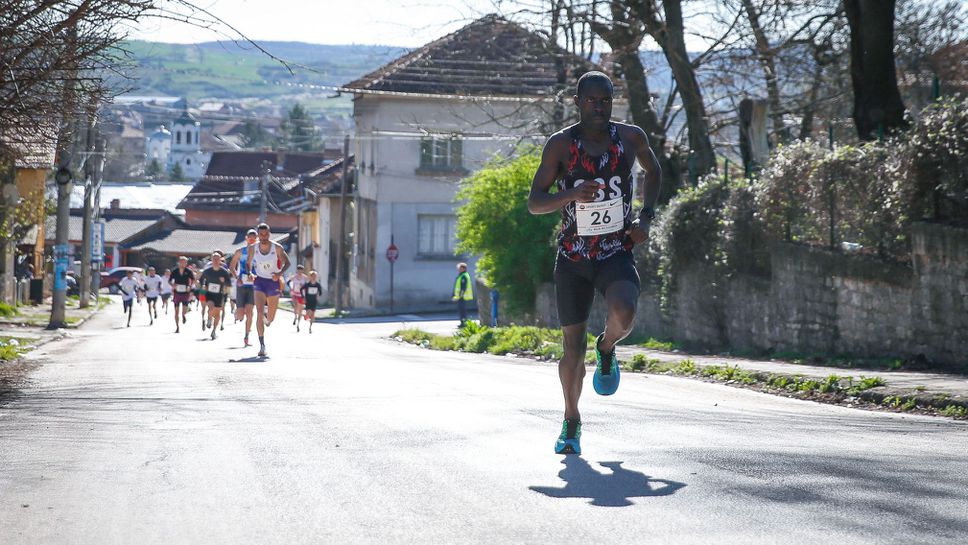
[245,223,289,356]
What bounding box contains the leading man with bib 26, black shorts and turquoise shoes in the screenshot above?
[528,72,659,454]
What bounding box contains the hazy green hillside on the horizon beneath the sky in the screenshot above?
[125,41,406,110]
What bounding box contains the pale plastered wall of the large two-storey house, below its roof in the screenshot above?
[350,95,580,309]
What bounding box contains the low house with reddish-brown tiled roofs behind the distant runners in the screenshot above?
[178,151,342,232]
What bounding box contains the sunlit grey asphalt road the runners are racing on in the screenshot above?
[0,307,968,545]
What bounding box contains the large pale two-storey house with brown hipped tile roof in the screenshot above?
[343,15,617,309]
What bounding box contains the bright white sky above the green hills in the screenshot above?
[130,0,495,47]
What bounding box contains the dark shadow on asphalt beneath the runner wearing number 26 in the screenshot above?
[528,456,686,507]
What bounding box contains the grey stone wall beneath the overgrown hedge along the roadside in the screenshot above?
[536,223,968,365]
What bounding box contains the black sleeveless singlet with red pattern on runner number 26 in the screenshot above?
[558,123,633,261]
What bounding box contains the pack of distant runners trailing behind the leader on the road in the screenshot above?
[118,223,322,357]
